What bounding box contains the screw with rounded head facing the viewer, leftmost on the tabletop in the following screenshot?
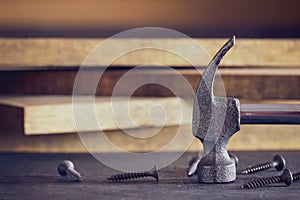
[57,160,81,181]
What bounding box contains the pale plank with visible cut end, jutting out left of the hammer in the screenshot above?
[0,96,191,135]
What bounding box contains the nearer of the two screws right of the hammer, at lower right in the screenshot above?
[241,169,293,189]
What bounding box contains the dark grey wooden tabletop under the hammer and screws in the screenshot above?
[0,151,300,200]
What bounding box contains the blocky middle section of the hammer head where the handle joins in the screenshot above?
[192,96,240,142]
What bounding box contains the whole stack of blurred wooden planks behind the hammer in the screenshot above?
[0,38,300,152]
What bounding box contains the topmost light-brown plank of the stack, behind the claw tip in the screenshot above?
[0,38,300,70]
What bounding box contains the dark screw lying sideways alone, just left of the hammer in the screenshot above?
[107,165,158,182]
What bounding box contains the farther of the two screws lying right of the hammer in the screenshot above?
[238,155,285,174]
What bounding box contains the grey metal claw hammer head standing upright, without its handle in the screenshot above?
[192,37,240,183]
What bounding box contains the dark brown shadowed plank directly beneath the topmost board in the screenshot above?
[0,68,300,101]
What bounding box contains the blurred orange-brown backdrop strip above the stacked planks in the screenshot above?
[0,0,300,37]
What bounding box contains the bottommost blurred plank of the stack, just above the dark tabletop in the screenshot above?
[0,125,300,153]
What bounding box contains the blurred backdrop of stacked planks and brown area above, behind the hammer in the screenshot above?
[0,0,300,152]
